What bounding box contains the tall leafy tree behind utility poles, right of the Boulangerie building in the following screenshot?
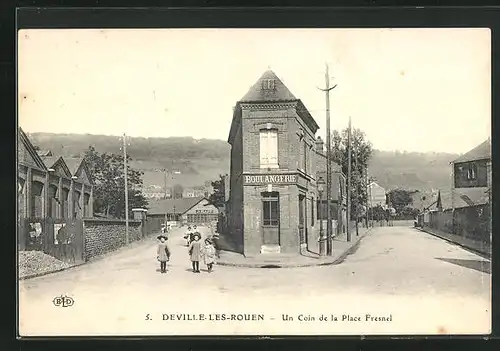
[331,128,373,217]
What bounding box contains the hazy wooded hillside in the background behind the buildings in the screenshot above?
[29,133,459,190]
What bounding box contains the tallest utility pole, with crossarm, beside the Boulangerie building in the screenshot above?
[320,64,337,256]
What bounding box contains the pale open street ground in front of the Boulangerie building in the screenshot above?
[19,227,491,335]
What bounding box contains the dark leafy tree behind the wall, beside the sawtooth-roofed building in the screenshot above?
[84,146,148,218]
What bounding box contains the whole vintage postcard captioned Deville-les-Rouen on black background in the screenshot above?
[17,28,492,337]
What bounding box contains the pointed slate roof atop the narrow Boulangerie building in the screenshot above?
[240,70,297,102]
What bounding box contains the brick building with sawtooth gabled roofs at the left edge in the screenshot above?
[17,128,94,219]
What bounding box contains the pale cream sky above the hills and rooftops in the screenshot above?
[18,28,491,153]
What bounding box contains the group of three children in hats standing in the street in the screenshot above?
[157,226,216,273]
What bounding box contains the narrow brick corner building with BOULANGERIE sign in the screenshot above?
[227,71,345,256]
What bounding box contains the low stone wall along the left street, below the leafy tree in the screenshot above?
[84,219,143,261]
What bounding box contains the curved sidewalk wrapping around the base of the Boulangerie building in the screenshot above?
[217,228,371,268]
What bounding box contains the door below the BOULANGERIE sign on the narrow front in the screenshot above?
[262,192,280,245]
